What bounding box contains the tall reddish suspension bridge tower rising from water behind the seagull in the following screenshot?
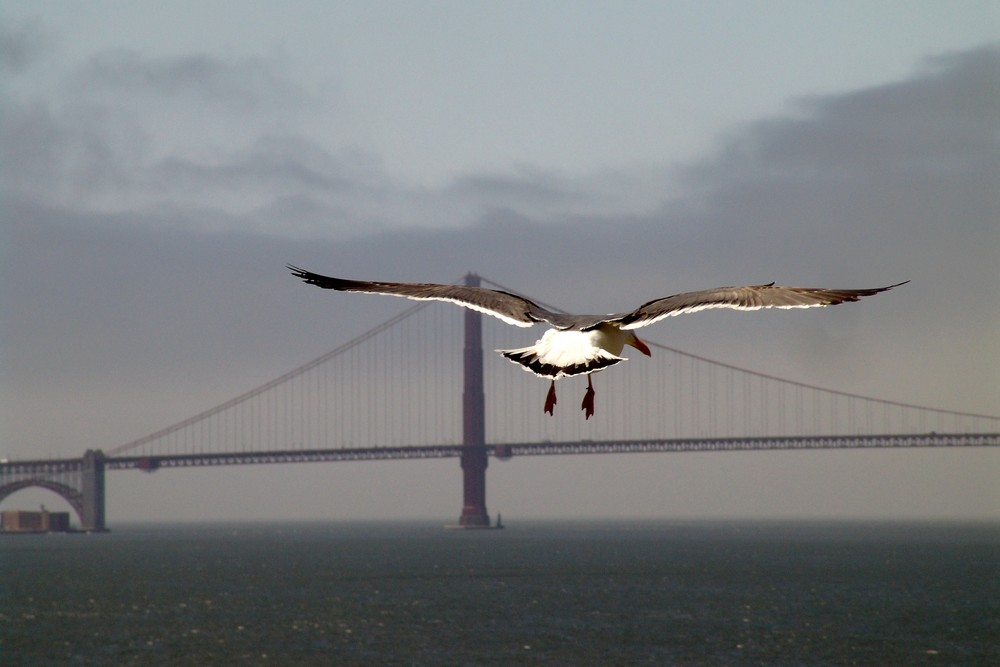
[458,273,490,528]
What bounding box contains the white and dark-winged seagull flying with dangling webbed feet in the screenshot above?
[288,264,909,419]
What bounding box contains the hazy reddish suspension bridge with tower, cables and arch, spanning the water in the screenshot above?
[0,274,1000,531]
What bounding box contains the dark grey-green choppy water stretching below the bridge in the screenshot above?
[0,522,1000,666]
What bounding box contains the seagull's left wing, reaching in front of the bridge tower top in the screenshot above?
[288,264,557,327]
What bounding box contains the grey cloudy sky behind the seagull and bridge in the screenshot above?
[0,0,1000,525]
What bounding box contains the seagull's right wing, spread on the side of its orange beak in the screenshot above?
[608,280,910,329]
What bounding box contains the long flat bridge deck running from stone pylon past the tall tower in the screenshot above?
[103,433,1000,472]
